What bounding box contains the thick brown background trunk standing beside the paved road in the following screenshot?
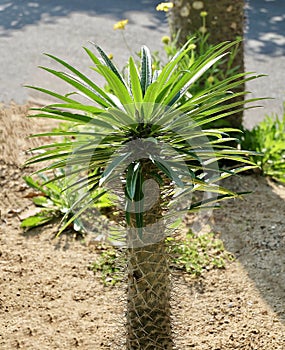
[169,0,245,127]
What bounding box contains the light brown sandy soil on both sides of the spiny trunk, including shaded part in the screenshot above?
[0,105,285,350]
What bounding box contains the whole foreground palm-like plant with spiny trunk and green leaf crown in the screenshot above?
[27,42,260,350]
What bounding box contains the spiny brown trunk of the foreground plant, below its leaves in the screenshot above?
[126,160,174,350]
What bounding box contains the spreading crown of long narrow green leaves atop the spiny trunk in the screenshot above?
[27,41,255,241]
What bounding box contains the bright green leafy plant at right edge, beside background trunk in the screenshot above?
[241,113,285,183]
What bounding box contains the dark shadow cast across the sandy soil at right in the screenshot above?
[214,176,285,323]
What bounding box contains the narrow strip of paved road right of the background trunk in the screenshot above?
[244,0,285,128]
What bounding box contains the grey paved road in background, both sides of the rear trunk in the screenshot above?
[0,0,285,127]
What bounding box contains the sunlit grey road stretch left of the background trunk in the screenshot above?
[0,0,167,103]
